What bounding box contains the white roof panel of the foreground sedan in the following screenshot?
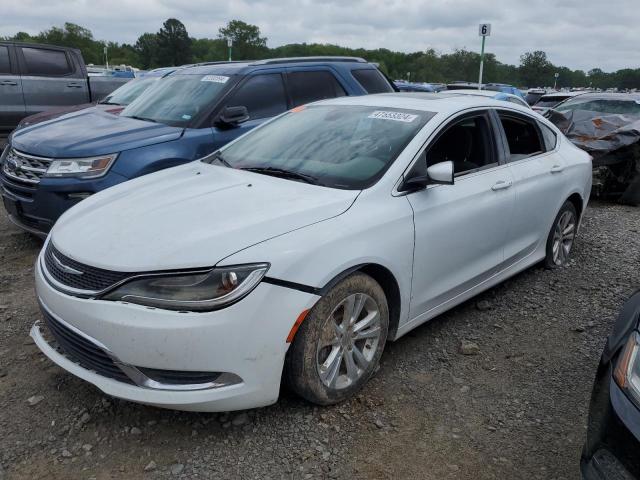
[319,92,531,114]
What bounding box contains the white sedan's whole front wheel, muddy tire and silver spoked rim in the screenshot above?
[284,272,389,405]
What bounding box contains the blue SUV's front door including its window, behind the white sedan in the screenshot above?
[213,72,289,150]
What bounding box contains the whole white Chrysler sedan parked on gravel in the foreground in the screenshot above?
[31,93,591,411]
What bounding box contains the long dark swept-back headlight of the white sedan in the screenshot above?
[102,263,269,312]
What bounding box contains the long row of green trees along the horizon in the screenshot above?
[4,18,640,89]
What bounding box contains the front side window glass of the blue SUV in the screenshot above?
[227,73,287,120]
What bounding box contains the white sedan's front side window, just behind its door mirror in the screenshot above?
[427,115,498,176]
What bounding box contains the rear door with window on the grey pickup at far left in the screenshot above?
[16,46,89,115]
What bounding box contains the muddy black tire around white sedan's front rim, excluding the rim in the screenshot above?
[284,272,389,405]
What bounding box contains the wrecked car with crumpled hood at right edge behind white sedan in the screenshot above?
[546,93,640,205]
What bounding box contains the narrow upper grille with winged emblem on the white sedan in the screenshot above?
[44,242,134,292]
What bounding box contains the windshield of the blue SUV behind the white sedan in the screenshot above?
[120,74,230,127]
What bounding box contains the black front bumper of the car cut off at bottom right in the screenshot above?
[580,365,640,480]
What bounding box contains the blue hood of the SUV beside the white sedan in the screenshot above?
[11,108,183,158]
